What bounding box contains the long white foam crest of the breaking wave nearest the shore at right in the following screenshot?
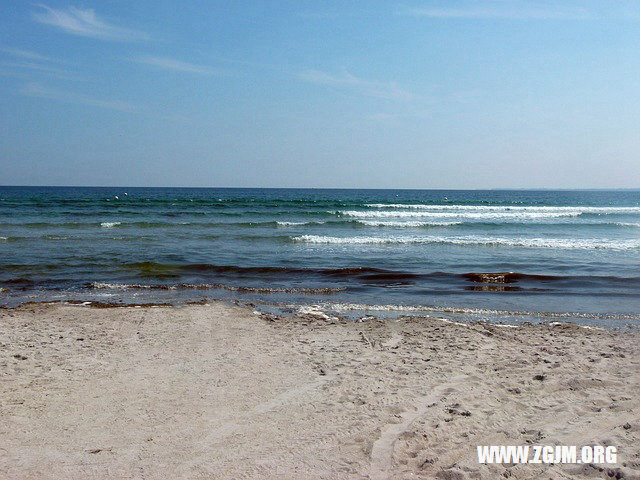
[292,235,640,250]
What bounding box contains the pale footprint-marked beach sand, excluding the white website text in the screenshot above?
[0,303,640,479]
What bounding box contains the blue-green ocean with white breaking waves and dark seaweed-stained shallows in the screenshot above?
[0,187,640,328]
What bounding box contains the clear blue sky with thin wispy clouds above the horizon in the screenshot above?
[0,0,640,188]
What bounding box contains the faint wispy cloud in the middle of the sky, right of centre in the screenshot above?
[298,70,415,100]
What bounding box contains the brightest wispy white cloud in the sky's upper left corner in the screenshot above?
[33,5,148,40]
